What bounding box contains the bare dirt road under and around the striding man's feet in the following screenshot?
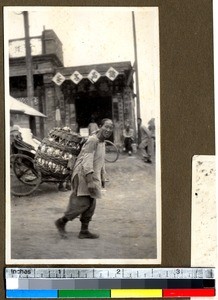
[11,155,157,259]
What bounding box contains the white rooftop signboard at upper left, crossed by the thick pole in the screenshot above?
[9,38,42,58]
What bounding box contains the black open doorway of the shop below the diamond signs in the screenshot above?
[75,96,112,128]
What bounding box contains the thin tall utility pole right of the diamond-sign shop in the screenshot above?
[132,11,141,143]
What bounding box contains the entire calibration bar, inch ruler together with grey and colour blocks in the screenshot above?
[5,268,215,299]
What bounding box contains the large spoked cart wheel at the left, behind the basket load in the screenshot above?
[10,154,42,196]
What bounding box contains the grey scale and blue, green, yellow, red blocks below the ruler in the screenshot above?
[6,278,215,298]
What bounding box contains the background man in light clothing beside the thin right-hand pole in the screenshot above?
[137,118,152,163]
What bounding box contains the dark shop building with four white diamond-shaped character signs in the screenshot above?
[9,30,135,144]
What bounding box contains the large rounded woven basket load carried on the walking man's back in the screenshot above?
[35,127,84,180]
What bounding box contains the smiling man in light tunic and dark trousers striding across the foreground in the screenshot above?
[55,119,113,239]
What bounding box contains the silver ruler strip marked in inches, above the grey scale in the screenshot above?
[5,267,215,279]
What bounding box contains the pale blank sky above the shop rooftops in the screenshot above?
[4,6,159,124]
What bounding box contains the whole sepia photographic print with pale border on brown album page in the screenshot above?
[4,6,162,265]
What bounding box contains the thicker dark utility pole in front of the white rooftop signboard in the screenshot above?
[23,11,36,135]
